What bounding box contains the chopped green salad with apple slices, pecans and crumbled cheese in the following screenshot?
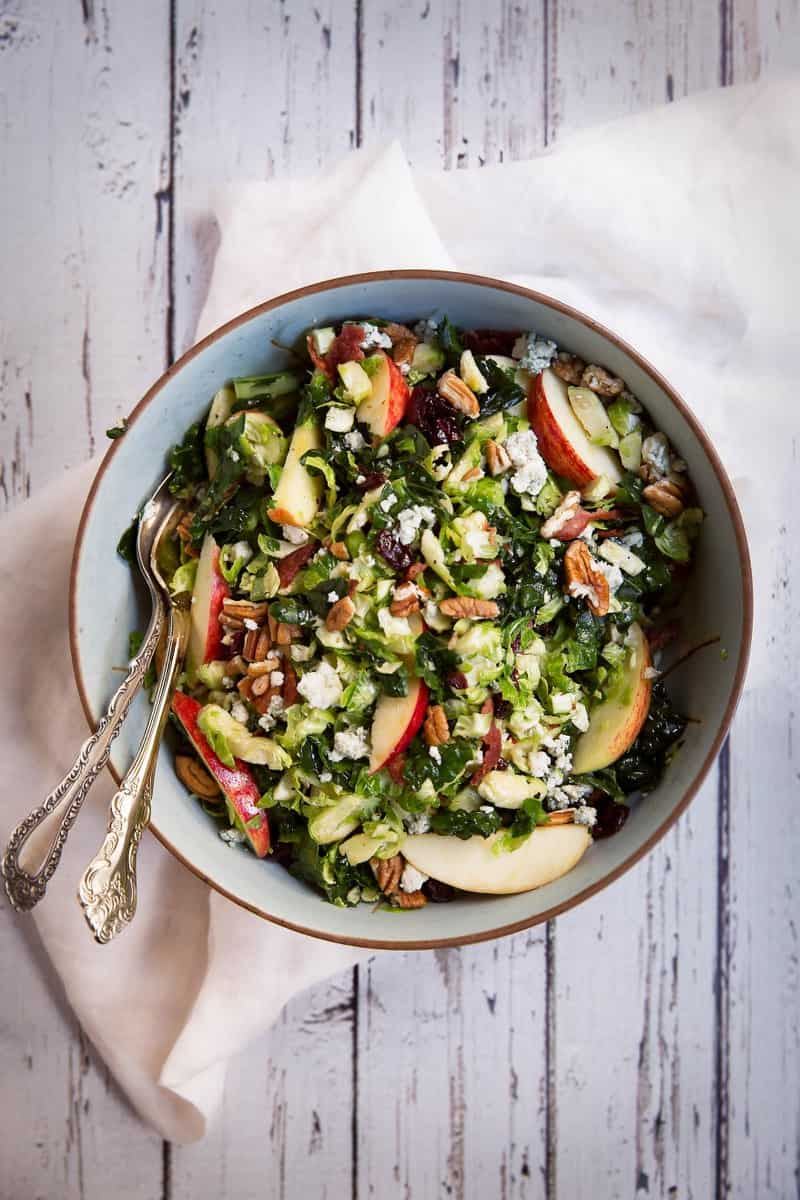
[142,316,703,908]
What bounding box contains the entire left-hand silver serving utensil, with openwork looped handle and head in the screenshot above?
[0,476,179,912]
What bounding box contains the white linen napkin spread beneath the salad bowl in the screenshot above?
[0,79,800,1141]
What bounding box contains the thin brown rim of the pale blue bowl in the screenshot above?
[70,270,753,950]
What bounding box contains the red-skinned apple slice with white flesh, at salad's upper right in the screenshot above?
[528,367,622,487]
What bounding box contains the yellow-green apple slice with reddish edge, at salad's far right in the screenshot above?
[572,624,652,775]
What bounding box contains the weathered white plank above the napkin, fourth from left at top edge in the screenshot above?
[547,0,720,142]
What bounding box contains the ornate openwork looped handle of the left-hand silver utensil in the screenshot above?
[0,596,166,912]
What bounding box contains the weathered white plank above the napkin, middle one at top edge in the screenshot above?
[361,0,545,167]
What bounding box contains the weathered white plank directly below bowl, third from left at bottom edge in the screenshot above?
[357,929,546,1200]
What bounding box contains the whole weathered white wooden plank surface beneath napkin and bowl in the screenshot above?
[0,0,800,1200]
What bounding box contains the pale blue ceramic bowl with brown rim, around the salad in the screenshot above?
[70,271,752,949]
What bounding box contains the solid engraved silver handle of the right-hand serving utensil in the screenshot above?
[78,607,188,943]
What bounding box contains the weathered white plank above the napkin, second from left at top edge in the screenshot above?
[175,0,356,353]
